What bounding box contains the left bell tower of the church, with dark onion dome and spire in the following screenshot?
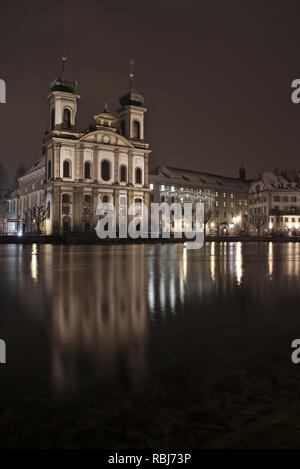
[48,56,80,133]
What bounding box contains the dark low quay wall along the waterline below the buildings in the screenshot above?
[0,233,300,245]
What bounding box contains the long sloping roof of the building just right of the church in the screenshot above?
[149,166,251,192]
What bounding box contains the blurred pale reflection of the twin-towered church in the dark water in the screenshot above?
[51,246,148,389]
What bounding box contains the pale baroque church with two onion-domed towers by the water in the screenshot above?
[10,57,151,234]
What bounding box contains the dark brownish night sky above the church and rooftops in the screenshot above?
[0,0,300,181]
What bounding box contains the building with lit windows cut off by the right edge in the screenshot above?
[248,170,300,234]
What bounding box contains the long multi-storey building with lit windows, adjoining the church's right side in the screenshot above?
[149,166,250,234]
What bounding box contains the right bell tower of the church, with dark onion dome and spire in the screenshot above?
[118,60,147,142]
